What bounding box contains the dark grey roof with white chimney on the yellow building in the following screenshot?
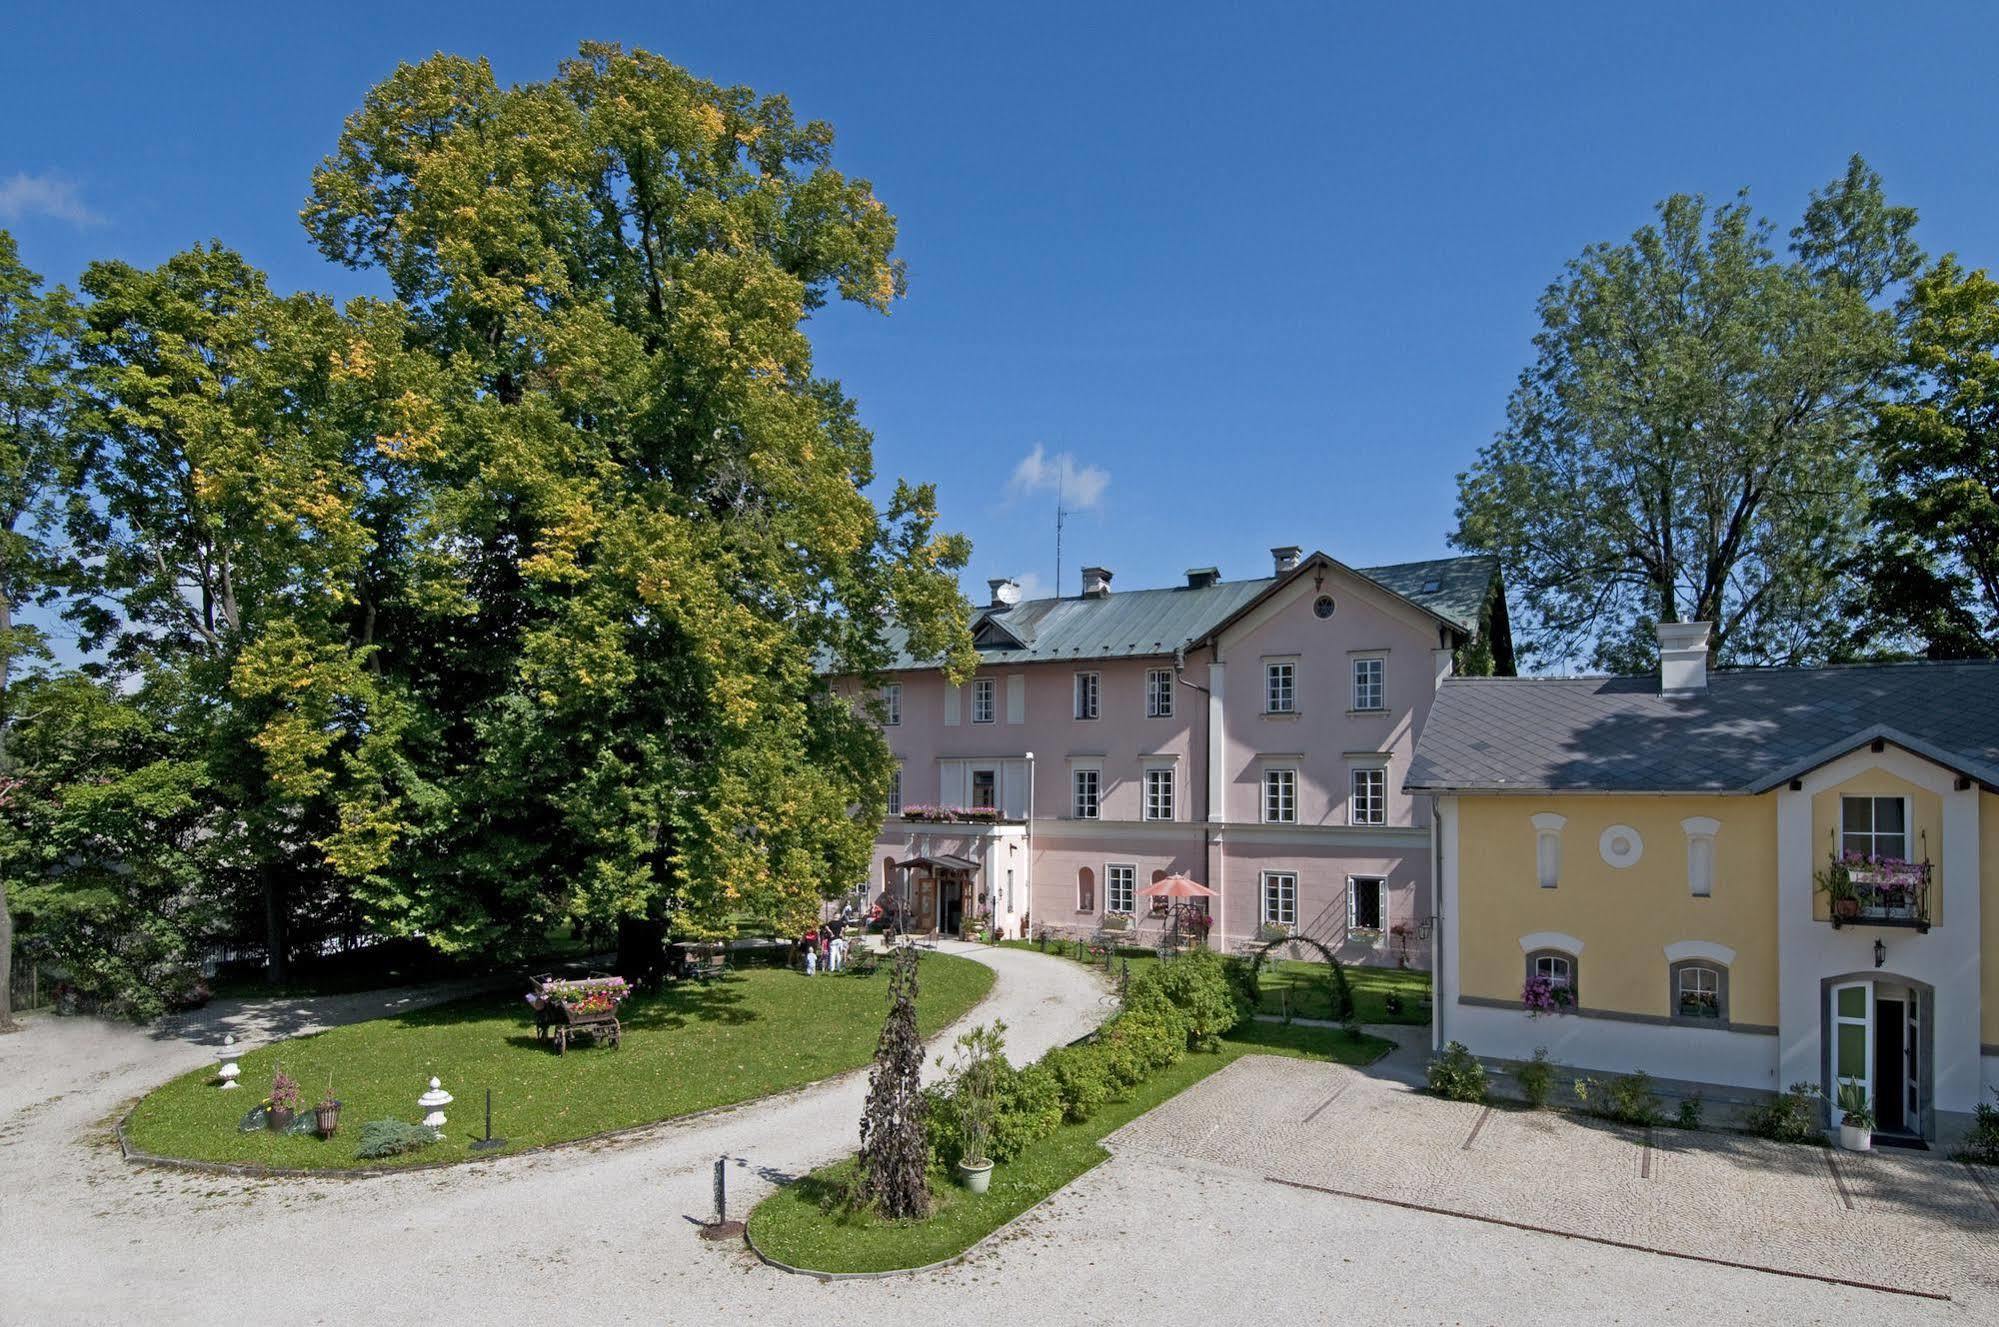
[1405,662,1999,793]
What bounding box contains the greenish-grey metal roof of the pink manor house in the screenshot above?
[890,556,1499,669]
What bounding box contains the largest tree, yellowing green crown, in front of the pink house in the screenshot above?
[304,44,972,963]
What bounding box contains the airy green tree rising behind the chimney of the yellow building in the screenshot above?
[1453,158,1921,669]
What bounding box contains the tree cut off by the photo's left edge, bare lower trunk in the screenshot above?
[0,230,76,1031]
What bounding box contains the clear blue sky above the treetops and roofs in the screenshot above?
[0,2,1999,596]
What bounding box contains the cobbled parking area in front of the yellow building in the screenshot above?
[1109,1055,1999,1305]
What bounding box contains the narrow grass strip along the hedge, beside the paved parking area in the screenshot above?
[750,1023,1389,1271]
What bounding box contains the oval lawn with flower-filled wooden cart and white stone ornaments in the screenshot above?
[130,953,994,1169]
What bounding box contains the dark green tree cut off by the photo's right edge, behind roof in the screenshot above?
[1865,258,1999,658]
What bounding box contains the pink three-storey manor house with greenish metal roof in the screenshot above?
[843,548,1513,967]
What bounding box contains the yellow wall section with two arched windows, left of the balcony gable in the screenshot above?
[1457,793,1777,1027]
